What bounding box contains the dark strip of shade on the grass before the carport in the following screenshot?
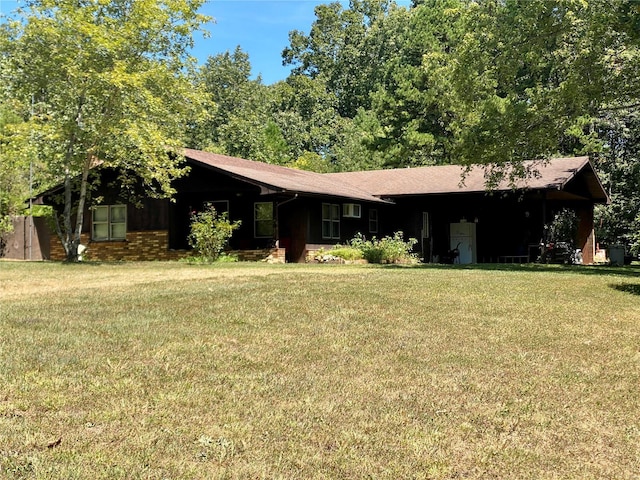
[400,263,640,278]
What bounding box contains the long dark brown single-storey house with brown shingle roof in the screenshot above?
[35,150,607,263]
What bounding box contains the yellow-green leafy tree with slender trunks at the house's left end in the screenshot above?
[0,0,207,261]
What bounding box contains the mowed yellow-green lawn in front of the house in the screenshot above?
[0,262,640,479]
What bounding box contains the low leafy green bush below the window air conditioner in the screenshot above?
[344,232,418,263]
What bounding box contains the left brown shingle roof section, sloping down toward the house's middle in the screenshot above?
[183,148,383,203]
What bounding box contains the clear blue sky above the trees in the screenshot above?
[0,0,409,85]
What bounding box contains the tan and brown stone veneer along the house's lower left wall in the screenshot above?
[50,230,285,262]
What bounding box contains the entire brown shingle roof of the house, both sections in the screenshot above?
[184,149,607,202]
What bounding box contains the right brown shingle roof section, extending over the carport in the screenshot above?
[327,157,607,201]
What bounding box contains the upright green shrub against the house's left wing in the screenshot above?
[188,204,240,263]
